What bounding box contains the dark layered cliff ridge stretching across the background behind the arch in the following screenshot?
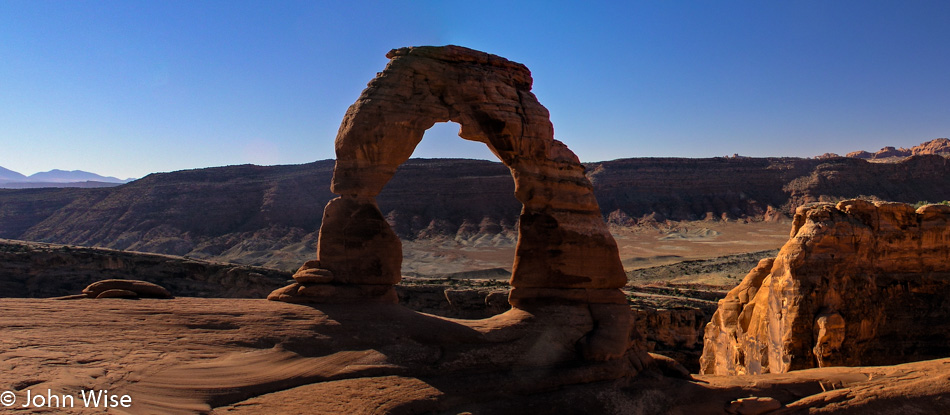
[0,155,950,270]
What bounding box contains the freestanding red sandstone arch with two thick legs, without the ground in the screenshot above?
[269,46,626,310]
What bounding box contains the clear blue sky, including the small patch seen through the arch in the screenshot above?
[0,0,950,178]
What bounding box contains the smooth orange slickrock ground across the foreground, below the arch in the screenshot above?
[0,298,950,415]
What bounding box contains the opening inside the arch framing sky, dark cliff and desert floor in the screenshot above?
[376,121,522,300]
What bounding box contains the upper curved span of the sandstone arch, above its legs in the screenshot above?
[331,46,556,196]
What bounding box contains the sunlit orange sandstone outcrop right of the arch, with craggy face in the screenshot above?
[701,200,950,375]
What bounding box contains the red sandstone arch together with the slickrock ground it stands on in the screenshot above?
[0,46,950,415]
